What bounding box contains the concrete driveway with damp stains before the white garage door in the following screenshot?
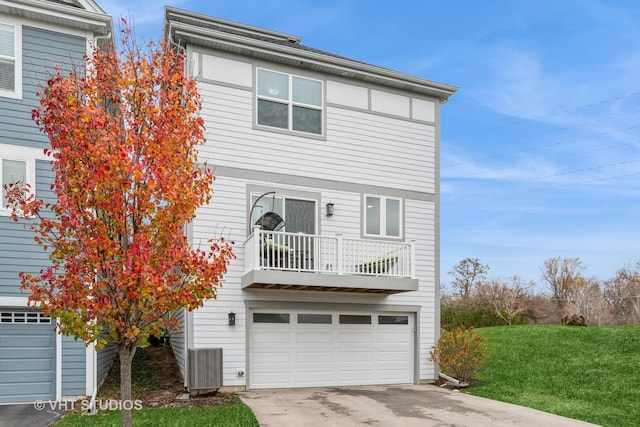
[238,385,594,427]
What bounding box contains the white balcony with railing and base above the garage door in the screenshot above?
[242,227,418,294]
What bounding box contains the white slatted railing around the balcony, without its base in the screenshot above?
[244,226,415,279]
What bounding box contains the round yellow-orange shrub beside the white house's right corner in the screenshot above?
[430,327,488,382]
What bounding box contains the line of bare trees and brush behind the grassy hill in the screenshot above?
[441,257,640,329]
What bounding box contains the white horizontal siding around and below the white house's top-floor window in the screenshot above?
[198,82,436,193]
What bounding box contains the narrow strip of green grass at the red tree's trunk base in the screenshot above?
[55,398,258,427]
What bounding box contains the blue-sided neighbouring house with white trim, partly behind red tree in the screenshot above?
[0,0,113,404]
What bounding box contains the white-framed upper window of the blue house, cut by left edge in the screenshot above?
[0,22,22,98]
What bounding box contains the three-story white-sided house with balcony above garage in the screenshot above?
[165,7,456,389]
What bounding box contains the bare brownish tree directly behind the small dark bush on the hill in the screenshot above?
[542,257,584,318]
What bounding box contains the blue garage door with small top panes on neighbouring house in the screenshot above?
[0,309,56,403]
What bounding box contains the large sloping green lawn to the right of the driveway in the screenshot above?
[468,325,640,426]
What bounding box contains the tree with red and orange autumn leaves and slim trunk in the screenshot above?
[7,22,233,426]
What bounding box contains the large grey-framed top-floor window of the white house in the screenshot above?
[257,68,324,135]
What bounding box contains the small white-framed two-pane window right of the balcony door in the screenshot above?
[364,195,402,239]
